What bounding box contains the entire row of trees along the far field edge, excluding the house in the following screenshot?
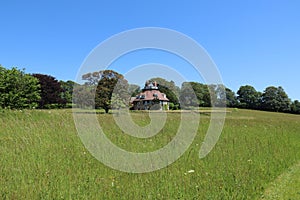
[0,65,300,114]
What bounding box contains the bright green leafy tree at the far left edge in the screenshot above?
[0,65,40,109]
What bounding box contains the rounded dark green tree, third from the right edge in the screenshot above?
[237,85,261,109]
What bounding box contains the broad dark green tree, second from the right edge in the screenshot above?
[262,86,291,112]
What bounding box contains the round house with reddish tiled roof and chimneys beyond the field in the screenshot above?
[131,81,169,110]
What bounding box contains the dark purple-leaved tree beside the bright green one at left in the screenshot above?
[32,74,66,108]
